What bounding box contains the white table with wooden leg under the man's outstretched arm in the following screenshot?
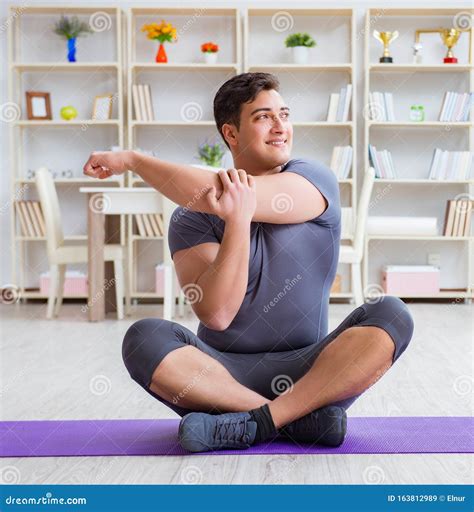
[79,187,177,321]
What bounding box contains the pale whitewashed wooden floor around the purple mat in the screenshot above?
[0,303,474,484]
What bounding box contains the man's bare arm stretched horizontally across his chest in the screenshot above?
[129,151,327,224]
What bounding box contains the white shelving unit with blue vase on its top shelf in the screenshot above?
[8,5,125,299]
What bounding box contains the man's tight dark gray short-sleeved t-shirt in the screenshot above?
[168,159,341,353]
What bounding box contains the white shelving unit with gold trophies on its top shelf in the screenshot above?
[363,8,474,300]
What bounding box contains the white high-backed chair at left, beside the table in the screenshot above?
[36,167,129,320]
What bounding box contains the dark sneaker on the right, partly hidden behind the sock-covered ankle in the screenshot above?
[280,405,347,446]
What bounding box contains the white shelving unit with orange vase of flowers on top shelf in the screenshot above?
[127,7,242,300]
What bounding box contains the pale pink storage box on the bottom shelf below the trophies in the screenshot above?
[382,265,439,296]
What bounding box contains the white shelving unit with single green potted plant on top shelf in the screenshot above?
[243,8,357,299]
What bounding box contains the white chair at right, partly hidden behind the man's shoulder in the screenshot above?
[339,167,375,306]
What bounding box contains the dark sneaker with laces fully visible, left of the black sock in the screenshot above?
[178,412,257,452]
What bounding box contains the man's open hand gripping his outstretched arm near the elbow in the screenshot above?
[207,169,257,224]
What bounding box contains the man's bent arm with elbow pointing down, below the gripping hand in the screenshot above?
[173,222,250,331]
